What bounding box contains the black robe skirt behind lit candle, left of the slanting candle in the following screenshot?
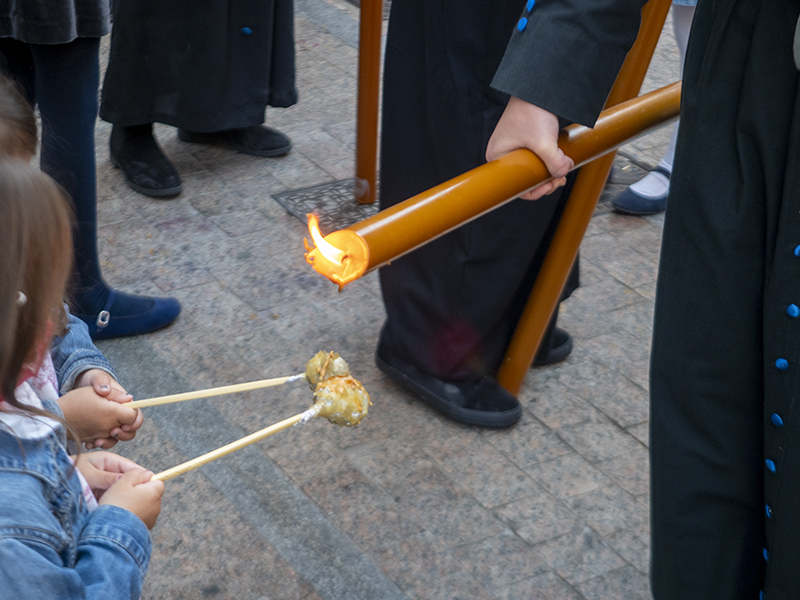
[380,0,575,380]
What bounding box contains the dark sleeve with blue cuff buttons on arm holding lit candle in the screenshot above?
[492,0,646,127]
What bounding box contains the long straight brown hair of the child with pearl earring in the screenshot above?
[0,158,72,412]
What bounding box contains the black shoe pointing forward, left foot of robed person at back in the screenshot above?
[109,123,182,198]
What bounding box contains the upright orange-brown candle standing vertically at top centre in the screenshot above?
[355,0,383,204]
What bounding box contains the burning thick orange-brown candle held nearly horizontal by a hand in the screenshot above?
[309,83,681,286]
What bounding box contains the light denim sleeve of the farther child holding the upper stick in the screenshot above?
[50,312,116,394]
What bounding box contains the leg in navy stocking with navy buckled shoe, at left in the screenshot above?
[30,38,180,339]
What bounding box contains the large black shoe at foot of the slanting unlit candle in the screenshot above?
[375,344,522,427]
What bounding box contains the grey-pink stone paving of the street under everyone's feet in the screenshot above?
[92,0,678,600]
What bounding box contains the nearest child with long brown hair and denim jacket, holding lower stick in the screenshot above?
[0,160,164,600]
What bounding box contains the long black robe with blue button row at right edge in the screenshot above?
[650,0,800,600]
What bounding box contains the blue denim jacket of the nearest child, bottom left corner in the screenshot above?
[0,400,151,600]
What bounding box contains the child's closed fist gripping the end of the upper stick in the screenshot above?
[58,387,144,448]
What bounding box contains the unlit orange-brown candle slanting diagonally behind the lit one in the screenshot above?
[497,0,671,395]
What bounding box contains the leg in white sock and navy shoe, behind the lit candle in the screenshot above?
[611,4,694,215]
